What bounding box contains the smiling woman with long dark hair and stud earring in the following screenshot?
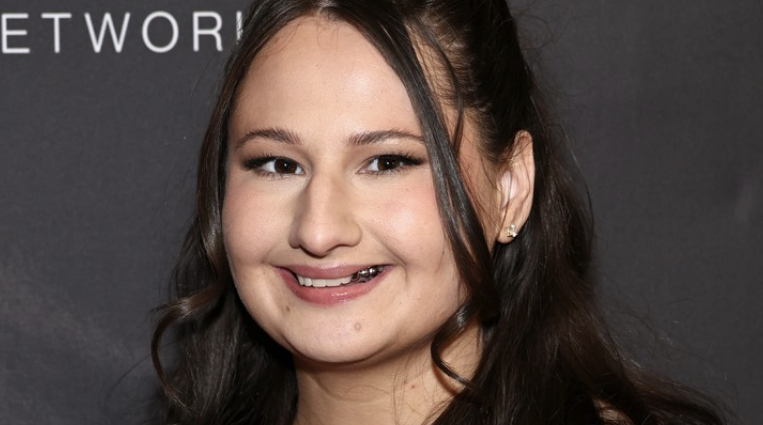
[153,0,722,425]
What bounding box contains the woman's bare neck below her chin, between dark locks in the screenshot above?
[295,326,480,425]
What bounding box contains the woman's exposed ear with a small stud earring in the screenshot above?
[496,130,535,243]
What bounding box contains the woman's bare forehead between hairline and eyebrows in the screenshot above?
[231,17,418,137]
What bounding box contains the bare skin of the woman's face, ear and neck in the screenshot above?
[223,18,534,424]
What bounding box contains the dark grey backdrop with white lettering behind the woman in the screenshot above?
[0,0,763,424]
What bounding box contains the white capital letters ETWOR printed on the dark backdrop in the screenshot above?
[0,11,242,55]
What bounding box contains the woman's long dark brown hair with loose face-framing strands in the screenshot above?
[152,0,722,425]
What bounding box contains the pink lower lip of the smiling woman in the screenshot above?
[278,266,390,305]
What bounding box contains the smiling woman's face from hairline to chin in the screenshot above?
[223,18,496,363]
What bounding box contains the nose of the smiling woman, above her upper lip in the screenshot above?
[289,171,362,257]
